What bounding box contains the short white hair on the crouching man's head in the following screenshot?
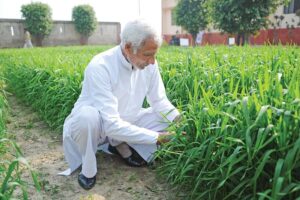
[120,19,162,53]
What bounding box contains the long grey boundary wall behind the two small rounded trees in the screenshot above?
[0,19,121,48]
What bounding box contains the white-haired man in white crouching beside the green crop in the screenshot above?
[63,20,179,189]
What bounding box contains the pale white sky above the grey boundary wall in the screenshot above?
[0,0,161,33]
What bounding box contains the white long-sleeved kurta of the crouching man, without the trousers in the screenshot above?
[64,46,179,175]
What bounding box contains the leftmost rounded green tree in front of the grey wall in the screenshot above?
[21,2,52,46]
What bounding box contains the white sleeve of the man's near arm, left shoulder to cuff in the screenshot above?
[83,65,158,144]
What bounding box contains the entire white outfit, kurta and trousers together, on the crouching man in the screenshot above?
[63,46,179,178]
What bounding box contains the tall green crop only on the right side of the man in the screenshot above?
[157,46,300,200]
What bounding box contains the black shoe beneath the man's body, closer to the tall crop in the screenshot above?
[108,145,147,167]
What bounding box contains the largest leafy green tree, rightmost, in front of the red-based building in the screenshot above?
[210,0,286,45]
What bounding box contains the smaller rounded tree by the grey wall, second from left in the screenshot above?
[72,5,97,44]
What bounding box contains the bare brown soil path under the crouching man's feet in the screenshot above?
[7,95,182,200]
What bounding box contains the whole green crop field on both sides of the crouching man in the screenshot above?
[0,46,300,200]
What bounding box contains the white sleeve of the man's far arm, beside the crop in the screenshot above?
[147,65,179,121]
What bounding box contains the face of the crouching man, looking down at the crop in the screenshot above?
[125,39,158,69]
